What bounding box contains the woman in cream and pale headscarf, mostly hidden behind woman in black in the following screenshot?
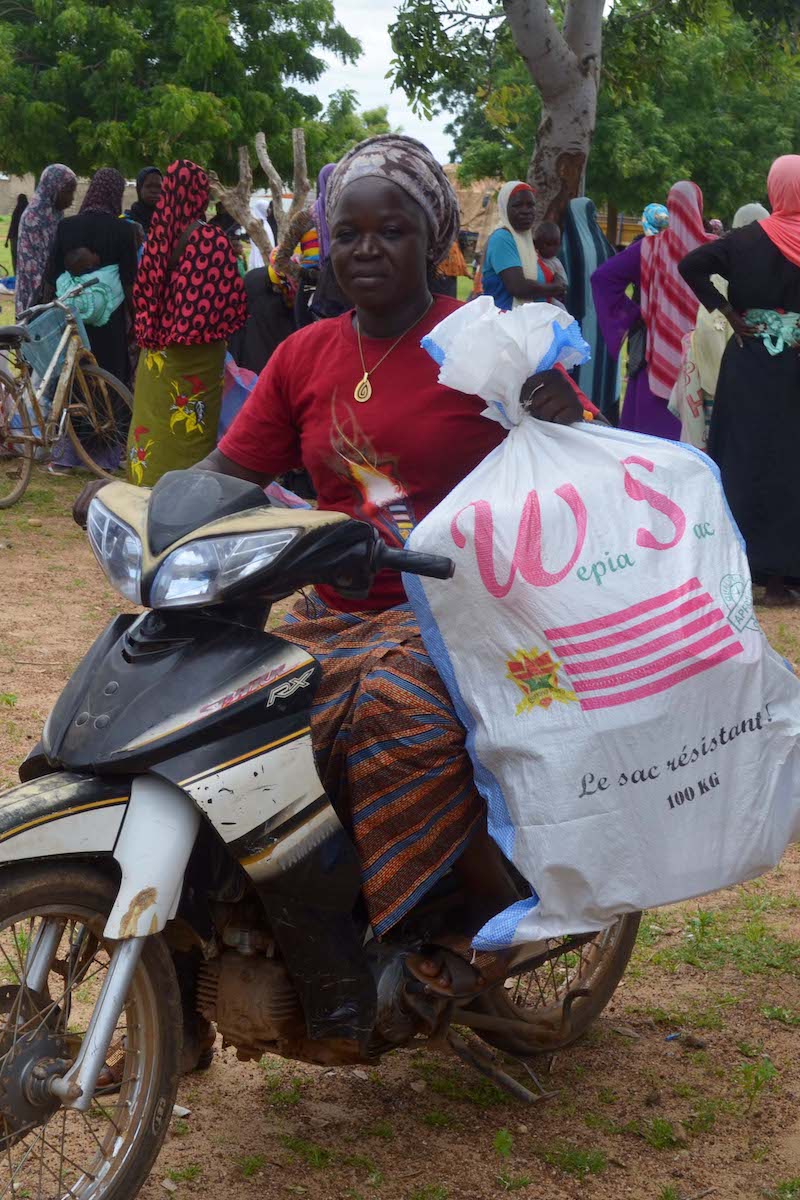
[669,204,769,450]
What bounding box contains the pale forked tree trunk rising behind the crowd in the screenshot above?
[504,0,603,223]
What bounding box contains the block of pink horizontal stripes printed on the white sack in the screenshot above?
[545,578,744,710]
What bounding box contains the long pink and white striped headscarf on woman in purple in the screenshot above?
[642,179,715,400]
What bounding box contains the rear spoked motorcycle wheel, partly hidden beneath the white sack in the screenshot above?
[469,912,642,1056]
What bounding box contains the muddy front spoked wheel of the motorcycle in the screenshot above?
[0,866,182,1200]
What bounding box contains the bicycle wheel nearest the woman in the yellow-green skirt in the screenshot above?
[66,361,133,479]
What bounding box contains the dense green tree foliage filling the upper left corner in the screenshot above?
[0,0,362,179]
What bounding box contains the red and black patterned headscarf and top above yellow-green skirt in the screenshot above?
[133,158,247,350]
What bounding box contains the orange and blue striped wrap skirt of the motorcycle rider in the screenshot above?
[275,593,485,936]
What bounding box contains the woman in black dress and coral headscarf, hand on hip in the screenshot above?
[680,155,800,605]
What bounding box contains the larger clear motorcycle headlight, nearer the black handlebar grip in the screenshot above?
[150,529,300,608]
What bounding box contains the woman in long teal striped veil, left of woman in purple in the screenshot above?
[561,196,619,424]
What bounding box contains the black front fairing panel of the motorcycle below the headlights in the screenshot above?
[43,612,319,774]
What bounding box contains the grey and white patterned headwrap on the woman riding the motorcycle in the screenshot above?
[326,133,459,263]
